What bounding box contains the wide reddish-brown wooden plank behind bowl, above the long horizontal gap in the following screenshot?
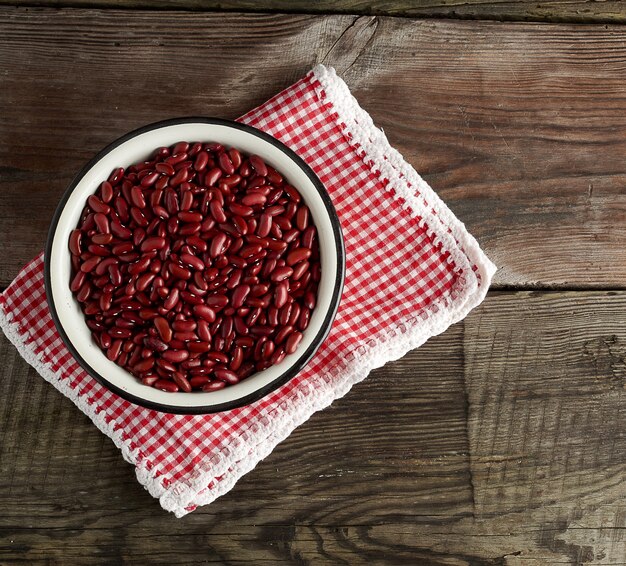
[0,8,626,289]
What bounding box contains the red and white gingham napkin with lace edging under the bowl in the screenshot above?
[0,66,495,517]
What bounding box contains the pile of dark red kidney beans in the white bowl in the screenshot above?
[69,142,321,392]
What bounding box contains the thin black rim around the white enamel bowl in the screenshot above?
[44,117,345,414]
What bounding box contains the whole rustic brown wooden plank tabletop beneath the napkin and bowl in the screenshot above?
[0,0,626,565]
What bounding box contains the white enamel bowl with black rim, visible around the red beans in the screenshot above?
[46,119,344,412]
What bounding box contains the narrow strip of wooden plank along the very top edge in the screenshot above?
[0,0,626,23]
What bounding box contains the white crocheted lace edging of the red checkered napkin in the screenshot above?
[0,65,496,517]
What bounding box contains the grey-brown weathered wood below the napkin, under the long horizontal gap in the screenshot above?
[0,292,626,566]
